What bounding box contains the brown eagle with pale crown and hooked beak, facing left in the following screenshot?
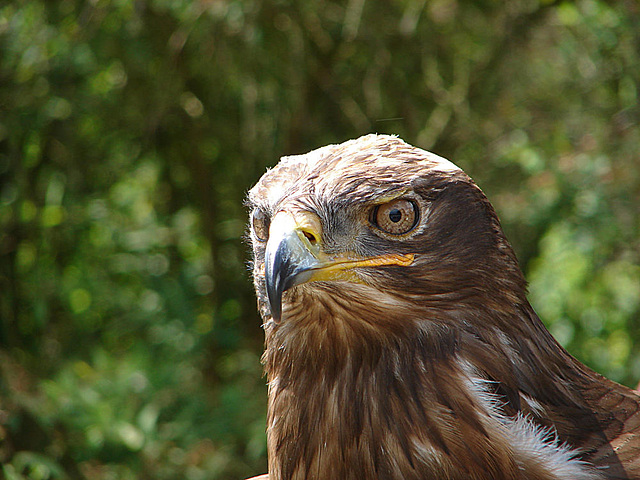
[248,135,640,480]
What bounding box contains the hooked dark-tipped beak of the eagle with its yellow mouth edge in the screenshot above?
[264,211,414,321]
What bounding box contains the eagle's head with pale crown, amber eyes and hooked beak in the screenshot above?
[249,135,525,330]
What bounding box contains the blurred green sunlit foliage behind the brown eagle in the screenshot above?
[0,0,640,480]
